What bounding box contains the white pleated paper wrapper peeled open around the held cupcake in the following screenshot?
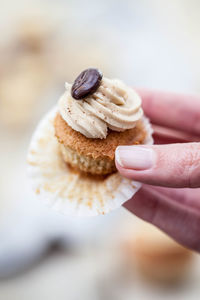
[28,108,153,216]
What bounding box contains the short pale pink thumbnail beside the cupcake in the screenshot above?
[115,146,155,170]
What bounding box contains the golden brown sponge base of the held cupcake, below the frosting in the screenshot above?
[54,113,146,175]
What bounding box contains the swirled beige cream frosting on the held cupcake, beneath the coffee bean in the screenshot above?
[58,77,143,139]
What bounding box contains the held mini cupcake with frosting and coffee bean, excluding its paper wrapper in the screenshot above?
[54,69,146,175]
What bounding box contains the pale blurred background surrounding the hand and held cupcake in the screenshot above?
[0,0,200,300]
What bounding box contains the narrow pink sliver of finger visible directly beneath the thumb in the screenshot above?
[143,185,200,211]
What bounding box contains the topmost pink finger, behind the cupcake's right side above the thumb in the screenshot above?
[137,89,200,135]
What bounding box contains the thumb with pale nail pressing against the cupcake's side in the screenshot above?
[115,143,200,188]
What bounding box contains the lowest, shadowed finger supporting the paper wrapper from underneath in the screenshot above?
[124,187,200,251]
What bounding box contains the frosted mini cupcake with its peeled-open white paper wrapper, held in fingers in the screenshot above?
[28,68,153,216]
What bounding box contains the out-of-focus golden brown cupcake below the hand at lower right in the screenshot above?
[123,222,193,284]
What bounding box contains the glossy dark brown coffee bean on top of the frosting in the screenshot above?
[71,68,103,100]
